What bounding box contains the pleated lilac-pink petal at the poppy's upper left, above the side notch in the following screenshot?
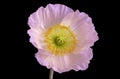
[28,4,73,29]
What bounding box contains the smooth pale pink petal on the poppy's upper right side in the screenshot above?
[61,10,98,48]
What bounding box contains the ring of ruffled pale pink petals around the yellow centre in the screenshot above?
[28,4,99,73]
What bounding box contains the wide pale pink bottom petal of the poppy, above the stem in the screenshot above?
[35,48,93,73]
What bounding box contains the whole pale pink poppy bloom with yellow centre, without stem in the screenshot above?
[28,4,98,73]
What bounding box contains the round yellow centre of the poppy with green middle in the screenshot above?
[45,24,77,56]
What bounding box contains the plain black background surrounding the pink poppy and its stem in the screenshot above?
[1,0,116,79]
